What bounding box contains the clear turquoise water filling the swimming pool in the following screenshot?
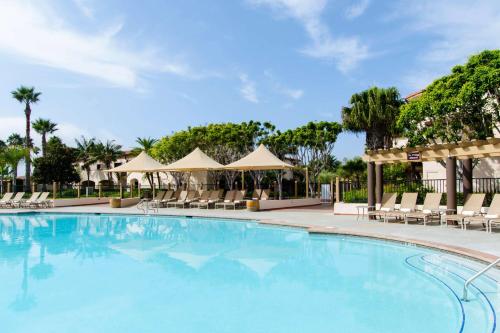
[0,214,500,333]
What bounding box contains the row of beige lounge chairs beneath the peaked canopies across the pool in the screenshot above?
[145,190,270,210]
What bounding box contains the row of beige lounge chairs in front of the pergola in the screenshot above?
[368,193,500,232]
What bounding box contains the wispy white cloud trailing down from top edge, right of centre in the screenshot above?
[248,0,370,72]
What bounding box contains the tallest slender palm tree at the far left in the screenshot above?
[12,86,42,192]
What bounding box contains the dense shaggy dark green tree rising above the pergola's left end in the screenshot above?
[342,87,402,150]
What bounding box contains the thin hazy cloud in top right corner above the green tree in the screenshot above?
[395,0,500,89]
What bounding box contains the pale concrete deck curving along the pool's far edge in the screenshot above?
[0,205,500,262]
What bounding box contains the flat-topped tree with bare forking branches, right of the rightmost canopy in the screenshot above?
[287,121,342,192]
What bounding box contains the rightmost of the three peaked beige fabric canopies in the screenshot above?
[224,144,293,170]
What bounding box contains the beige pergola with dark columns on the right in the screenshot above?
[363,138,500,211]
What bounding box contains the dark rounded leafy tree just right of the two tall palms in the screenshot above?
[33,137,80,184]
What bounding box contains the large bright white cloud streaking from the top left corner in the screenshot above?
[0,0,196,88]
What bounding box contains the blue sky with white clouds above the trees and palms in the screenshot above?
[0,0,500,159]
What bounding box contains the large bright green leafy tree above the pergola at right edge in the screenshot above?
[398,50,500,146]
